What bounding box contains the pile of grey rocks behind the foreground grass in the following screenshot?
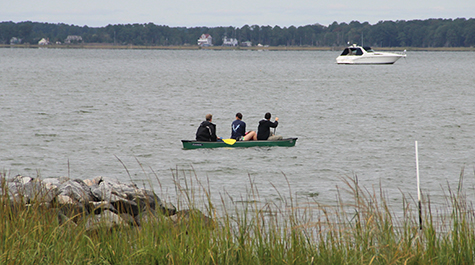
[0,175,211,230]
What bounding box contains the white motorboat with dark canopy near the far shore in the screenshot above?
[336,44,406,64]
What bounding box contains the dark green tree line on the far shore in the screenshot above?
[0,18,475,47]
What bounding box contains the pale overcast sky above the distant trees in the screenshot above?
[0,0,475,27]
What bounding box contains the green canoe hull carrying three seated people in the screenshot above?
[181,138,297,149]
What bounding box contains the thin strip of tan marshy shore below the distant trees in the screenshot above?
[0,43,475,52]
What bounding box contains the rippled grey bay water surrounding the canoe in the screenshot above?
[0,49,475,208]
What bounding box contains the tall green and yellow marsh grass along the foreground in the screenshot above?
[0,171,475,264]
